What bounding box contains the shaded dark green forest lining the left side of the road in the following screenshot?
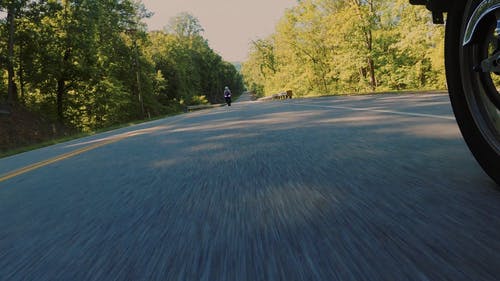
[0,0,243,131]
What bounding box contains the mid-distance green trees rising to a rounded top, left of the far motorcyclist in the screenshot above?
[146,13,243,105]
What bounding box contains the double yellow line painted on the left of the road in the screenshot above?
[0,136,127,182]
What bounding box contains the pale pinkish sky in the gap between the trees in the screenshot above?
[142,0,297,62]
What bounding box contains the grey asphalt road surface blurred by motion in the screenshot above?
[0,95,500,281]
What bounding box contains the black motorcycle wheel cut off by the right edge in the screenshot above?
[445,0,500,186]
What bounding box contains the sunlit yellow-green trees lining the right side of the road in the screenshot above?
[242,0,446,96]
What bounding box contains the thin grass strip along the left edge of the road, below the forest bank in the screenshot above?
[0,112,182,159]
